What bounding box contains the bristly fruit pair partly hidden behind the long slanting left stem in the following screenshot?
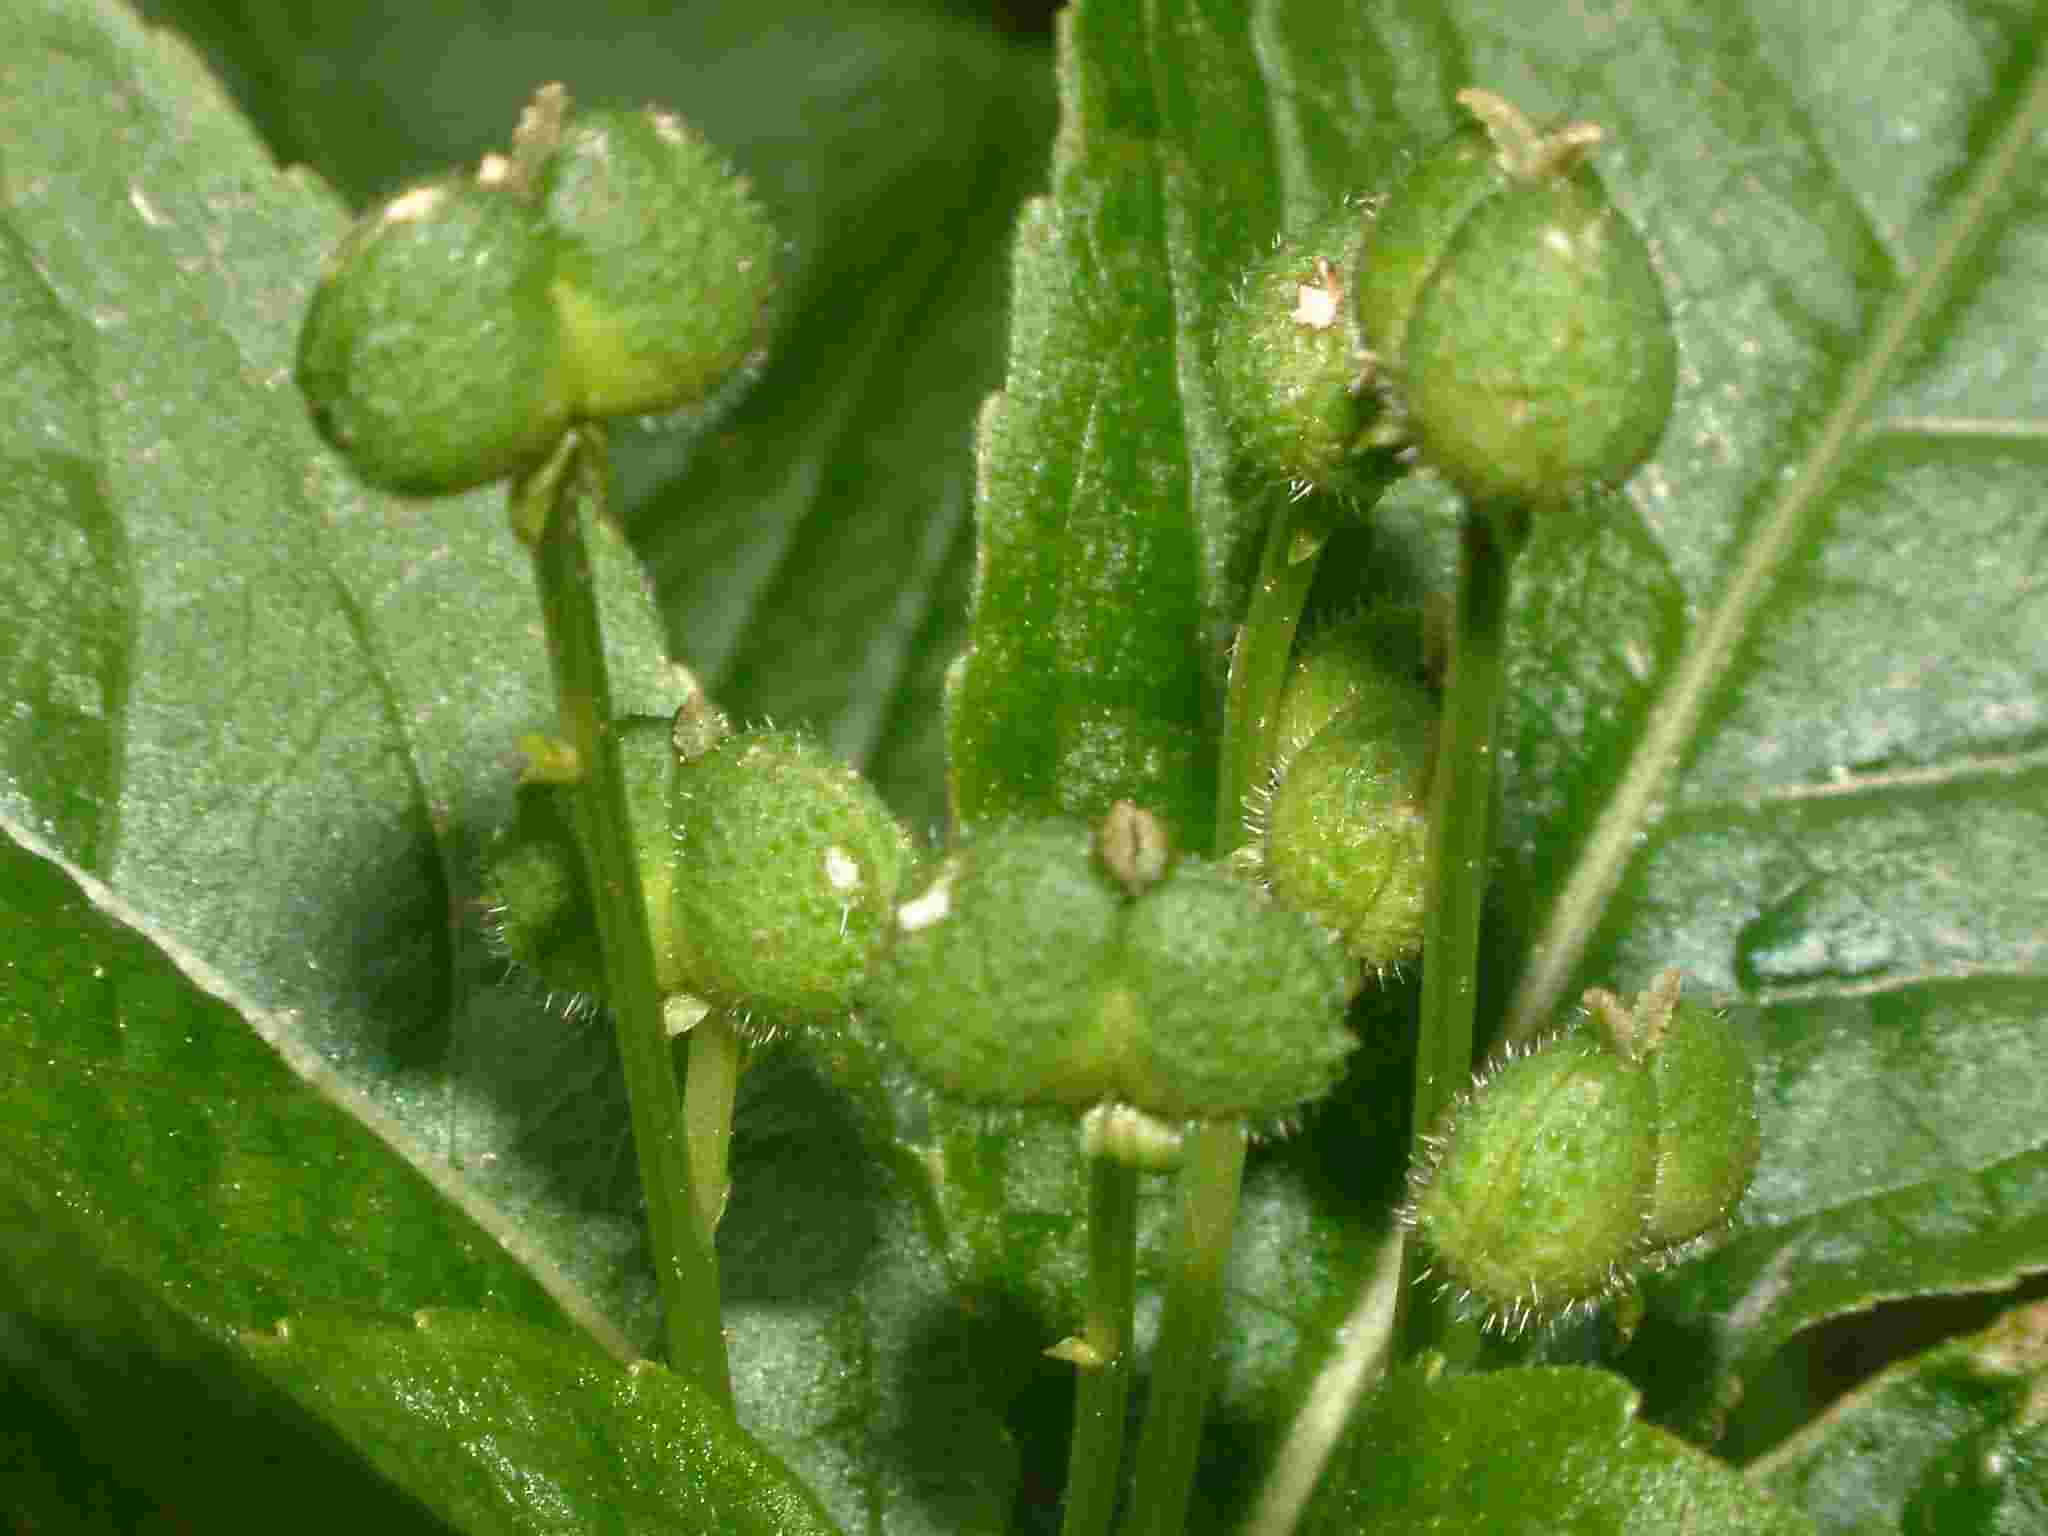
[485,715,911,1032]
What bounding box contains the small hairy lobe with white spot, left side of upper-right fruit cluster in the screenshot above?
[1217,205,1380,492]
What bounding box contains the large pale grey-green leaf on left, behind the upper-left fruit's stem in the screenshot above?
[0,0,688,1337]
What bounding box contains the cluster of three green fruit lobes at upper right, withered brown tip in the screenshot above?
[1217,90,1677,506]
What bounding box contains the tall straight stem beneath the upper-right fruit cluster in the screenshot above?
[1403,510,1516,1346]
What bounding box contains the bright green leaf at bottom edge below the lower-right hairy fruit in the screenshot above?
[1300,1366,1812,1536]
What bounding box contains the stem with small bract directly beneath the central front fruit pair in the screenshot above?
[1061,1157,1139,1536]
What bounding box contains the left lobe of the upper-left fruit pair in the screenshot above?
[297,178,571,496]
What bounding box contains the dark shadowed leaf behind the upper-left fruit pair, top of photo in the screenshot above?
[132,0,1053,829]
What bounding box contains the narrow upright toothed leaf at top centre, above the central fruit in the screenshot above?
[948,6,1274,850]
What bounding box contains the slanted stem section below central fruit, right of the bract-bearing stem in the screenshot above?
[1126,1120,1245,1536]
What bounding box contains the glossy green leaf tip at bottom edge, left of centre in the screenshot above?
[238,1311,834,1536]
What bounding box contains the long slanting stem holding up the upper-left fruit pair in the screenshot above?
[510,430,733,1403]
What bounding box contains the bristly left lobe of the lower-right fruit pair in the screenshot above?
[1409,1036,1657,1329]
